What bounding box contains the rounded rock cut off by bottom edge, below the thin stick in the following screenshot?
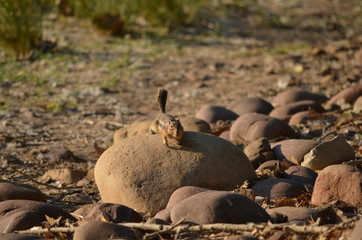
[73,221,137,240]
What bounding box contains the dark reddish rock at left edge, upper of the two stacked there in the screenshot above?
[0,182,46,202]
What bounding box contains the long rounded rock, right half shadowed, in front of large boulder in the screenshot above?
[171,191,269,224]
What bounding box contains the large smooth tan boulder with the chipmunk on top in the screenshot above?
[95,131,255,214]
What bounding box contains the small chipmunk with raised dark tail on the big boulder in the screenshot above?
[148,89,184,147]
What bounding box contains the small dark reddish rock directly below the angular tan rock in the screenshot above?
[283,166,318,186]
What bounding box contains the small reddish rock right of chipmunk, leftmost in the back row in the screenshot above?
[195,105,238,124]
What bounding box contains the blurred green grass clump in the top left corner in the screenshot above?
[0,0,46,59]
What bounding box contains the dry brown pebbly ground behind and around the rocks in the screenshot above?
[0,1,362,239]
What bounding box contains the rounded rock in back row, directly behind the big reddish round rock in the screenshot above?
[226,97,274,116]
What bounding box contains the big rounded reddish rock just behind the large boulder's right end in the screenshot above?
[230,113,295,144]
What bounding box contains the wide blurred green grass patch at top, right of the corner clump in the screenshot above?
[68,0,206,34]
